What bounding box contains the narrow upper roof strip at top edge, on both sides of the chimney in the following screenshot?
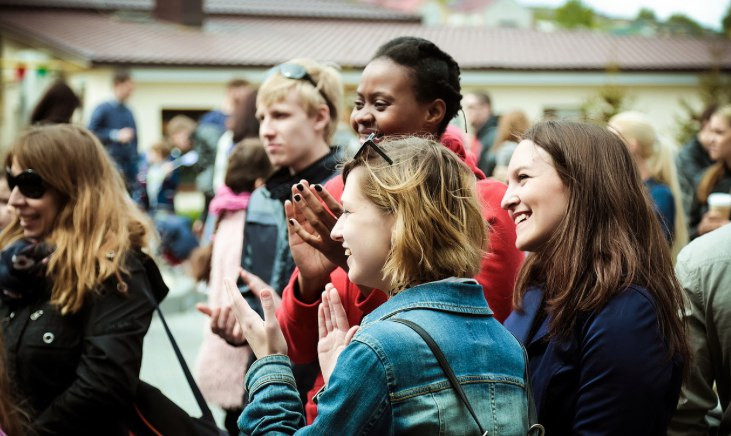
[0,0,421,22]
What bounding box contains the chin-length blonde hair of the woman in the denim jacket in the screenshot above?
[343,137,487,294]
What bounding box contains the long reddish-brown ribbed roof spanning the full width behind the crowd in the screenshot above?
[0,7,731,71]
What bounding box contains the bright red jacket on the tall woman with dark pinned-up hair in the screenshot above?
[277,134,523,424]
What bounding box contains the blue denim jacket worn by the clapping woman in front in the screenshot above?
[239,279,528,435]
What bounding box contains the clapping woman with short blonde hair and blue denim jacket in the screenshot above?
[227,137,530,435]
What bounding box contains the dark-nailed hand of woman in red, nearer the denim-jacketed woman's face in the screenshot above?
[287,180,348,270]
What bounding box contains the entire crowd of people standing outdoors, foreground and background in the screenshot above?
[0,37,731,436]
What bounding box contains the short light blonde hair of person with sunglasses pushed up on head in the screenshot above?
[256,58,343,144]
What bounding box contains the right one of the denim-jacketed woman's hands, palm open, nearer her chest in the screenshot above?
[317,283,360,385]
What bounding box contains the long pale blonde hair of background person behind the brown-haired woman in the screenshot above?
[609,111,688,259]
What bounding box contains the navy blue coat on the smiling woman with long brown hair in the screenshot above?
[505,286,683,436]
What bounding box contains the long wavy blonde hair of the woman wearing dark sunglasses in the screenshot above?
[0,124,151,314]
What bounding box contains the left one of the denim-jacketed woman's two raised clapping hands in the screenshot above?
[224,278,287,359]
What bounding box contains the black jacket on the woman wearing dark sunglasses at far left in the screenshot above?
[0,252,168,435]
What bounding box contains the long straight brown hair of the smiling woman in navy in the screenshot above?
[515,121,689,362]
